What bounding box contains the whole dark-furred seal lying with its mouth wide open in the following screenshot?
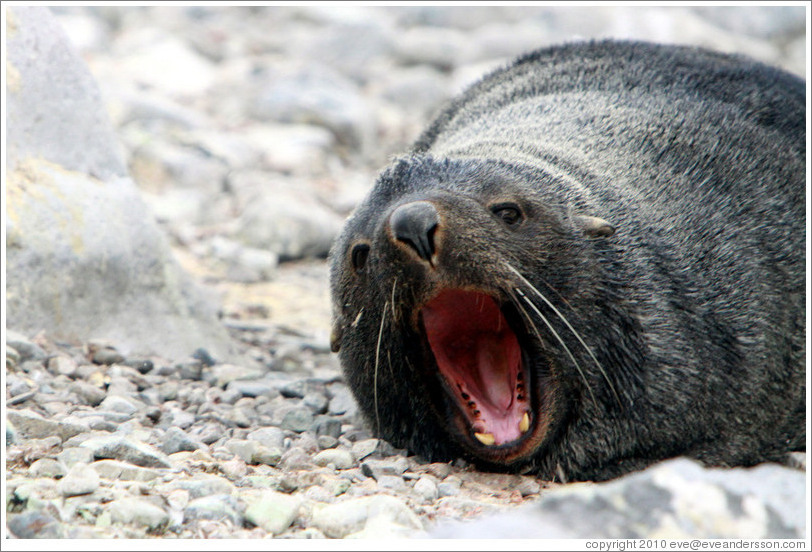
[331,41,806,480]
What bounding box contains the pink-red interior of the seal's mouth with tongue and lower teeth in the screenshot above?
[421,290,529,445]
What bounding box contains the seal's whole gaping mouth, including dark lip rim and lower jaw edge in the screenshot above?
[420,289,546,463]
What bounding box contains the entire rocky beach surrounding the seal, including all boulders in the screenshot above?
[4,5,809,542]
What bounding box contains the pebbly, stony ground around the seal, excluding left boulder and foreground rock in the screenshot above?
[5,7,806,538]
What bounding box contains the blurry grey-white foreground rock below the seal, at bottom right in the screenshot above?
[430,458,807,539]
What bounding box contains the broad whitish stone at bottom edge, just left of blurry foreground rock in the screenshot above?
[311,495,423,539]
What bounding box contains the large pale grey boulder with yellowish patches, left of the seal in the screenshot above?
[6,6,238,357]
